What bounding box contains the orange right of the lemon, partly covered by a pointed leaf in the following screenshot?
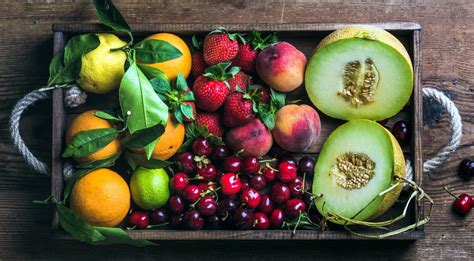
[139,33,191,81]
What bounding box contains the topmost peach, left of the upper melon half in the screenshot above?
[255,42,306,92]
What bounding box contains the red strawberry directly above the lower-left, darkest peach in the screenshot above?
[224,92,255,128]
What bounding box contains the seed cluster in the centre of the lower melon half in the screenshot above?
[331,152,375,190]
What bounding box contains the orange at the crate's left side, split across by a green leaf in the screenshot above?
[66,110,120,163]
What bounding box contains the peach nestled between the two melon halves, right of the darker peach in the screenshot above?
[272,104,321,152]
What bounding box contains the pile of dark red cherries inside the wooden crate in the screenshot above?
[132,137,316,230]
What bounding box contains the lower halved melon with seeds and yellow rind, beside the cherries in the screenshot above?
[313,120,405,224]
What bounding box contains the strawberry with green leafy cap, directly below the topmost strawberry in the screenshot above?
[193,62,240,112]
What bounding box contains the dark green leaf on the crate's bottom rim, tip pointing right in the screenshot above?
[94,227,157,247]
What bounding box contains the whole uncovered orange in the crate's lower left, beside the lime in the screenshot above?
[70,168,130,227]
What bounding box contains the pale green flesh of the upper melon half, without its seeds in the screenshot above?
[305,31,413,120]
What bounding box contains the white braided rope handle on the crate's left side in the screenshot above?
[9,90,49,175]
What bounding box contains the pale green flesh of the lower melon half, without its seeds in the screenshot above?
[313,120,396,224]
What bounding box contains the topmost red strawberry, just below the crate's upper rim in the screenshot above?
[203,30,239,65]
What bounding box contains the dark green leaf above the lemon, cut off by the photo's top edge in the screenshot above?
[93,0,131,34]
